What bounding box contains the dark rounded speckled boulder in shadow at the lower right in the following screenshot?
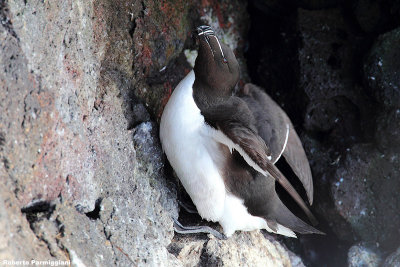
[332,145,400,249]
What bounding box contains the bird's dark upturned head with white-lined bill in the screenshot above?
[194,26,239,96]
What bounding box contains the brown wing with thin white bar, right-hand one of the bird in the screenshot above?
[241,83,314,204]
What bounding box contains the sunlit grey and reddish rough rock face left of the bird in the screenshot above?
[0,1,177,266]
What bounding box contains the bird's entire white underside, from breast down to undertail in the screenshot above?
[160,71,295,239]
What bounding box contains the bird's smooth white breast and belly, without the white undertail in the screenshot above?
[160,71,225,221]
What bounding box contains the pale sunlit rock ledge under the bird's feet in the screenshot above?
[169,231,304,267]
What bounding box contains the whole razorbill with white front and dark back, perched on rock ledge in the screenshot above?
[160,26,322,237]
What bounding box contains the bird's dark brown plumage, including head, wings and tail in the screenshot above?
[193,25,321,233]
